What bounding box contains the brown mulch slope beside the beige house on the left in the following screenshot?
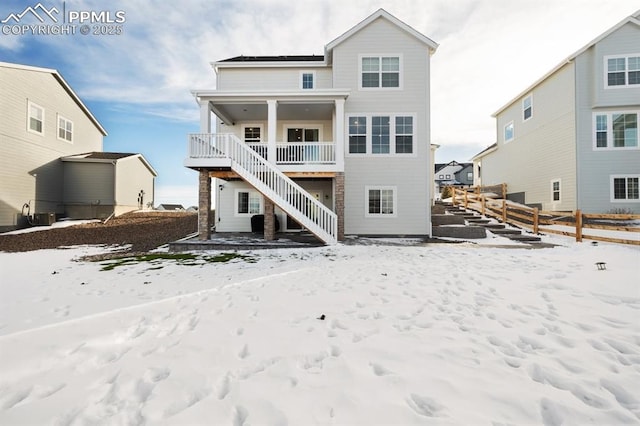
[0,212,198,253]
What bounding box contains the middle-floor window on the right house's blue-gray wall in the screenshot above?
[593,111,640,149]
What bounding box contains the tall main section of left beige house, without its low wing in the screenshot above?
[0,63,107,229]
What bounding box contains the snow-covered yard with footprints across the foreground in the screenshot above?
[0,239,640,426]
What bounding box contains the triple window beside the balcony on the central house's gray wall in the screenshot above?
[349,115,415,155]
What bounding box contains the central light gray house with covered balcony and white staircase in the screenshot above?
[184,9,437,243]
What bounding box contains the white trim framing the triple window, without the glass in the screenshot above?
[344,112,418,158]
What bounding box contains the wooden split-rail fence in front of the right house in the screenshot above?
[451,184,640,245]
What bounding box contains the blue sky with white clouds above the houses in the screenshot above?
[0,0,638,206]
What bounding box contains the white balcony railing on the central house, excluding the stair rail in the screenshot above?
[189,133,336,165]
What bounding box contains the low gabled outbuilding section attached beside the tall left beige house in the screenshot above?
[61,152,158,219]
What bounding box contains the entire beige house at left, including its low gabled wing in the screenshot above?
[0,62,157,231]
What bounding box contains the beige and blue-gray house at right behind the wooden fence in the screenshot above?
[473,11,640,213]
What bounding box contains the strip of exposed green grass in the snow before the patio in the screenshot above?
[100,253,256,271]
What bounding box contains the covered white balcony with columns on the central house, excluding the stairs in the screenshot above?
[184,90,349,173]
